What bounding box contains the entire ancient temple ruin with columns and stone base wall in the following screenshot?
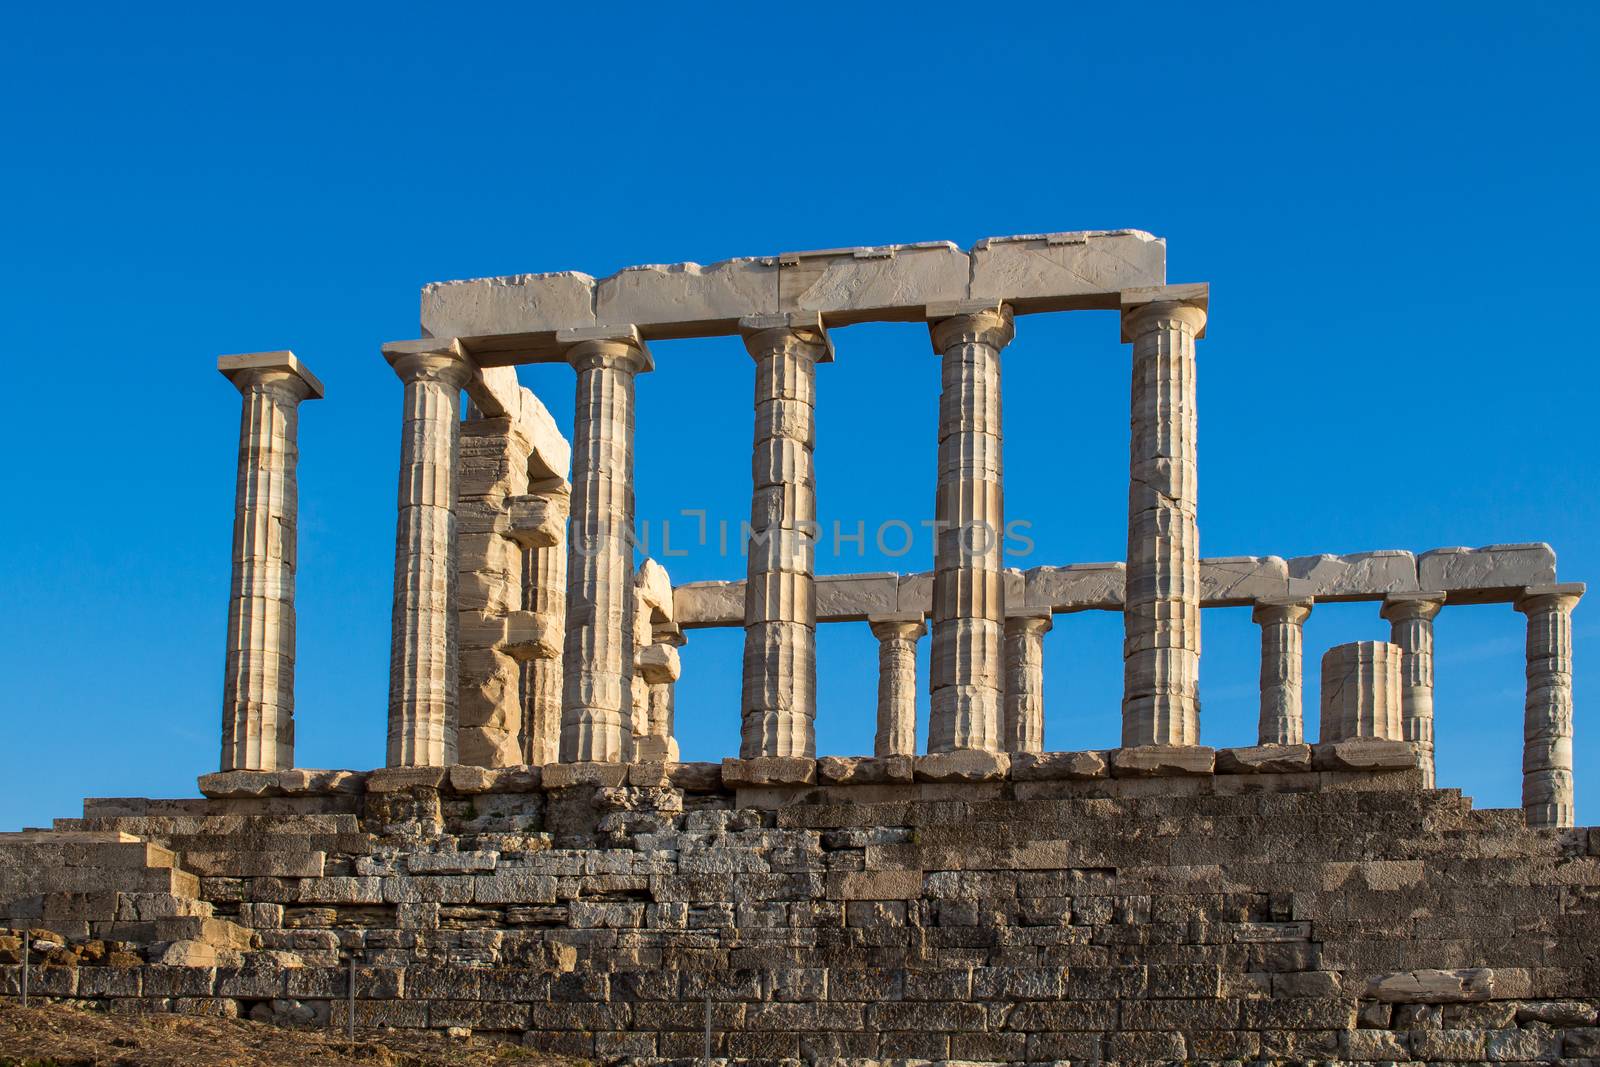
[0,230,1600,1062]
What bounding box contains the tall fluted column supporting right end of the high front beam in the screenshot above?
[1122,286,1206,745]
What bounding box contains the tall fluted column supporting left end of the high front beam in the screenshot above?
[384,339,472,766]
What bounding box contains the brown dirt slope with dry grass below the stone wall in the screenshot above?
[0,1000,578,1067]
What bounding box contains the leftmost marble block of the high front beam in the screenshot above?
[422,270,595,338]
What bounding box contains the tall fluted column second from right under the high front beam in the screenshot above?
[928,304,1014,752]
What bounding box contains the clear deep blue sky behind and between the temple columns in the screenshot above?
[0,3,1600,829]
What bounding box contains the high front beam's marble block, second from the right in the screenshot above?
[778,242,971,323]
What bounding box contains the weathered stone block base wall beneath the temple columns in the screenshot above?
[0,742,1600,1064]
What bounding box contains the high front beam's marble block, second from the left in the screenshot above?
[595,256,778,338]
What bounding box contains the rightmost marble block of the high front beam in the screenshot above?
[968,230,1166,312]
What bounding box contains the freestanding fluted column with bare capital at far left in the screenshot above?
[216,352,322,771]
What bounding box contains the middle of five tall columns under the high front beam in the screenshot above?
[739,315,832,758]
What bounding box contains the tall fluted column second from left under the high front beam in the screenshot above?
[562,328,654,763]
